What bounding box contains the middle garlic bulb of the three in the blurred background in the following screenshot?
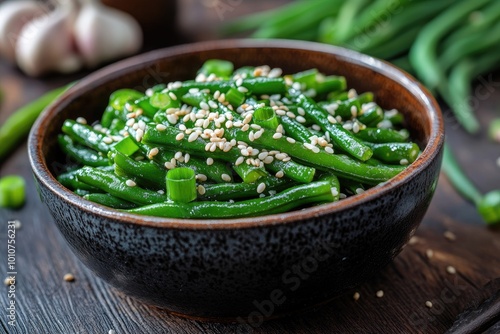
[16,2,82,76]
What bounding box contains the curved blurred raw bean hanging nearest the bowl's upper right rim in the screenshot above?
[410,0,489,90]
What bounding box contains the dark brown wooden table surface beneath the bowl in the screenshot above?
[0,1,500,334]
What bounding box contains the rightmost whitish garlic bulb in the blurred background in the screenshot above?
[73,0,142,68]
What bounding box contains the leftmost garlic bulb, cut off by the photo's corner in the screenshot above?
[0,0,47,62]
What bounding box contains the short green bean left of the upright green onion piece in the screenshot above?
[76,166,167,205]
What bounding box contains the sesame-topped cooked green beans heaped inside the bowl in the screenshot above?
[58,59,420,219]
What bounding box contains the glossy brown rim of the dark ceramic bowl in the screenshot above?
[28,39,444,230]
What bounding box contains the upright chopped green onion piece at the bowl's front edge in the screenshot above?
[167,167,197,203]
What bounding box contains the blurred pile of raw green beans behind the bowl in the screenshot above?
[221,0,500,133]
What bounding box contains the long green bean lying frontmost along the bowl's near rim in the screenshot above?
[127,181,333,219]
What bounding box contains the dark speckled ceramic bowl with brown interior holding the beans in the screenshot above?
[29,40,444,323]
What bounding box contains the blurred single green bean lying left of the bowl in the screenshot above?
[0,83,73,161]
